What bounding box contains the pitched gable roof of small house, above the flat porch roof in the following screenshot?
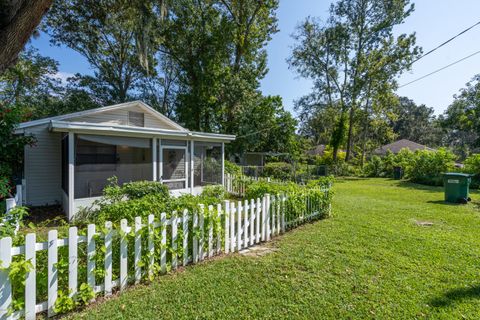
[17,100,188,132]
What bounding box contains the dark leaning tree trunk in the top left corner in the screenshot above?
[0,0,53,74]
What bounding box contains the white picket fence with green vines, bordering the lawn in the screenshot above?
[0,191,328,319]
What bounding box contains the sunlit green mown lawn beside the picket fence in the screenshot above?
[67,179,480,319]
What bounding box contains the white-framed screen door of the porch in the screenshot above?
[160,146,188,190]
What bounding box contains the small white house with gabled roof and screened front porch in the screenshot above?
[16,101,235,219]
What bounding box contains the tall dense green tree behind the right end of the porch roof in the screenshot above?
[162,0,278,133]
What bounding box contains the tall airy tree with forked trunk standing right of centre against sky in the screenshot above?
[289,0,419,160]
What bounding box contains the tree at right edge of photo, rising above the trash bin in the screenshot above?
[440,75,480,158]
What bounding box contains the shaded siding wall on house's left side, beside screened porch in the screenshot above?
[24,125,62,206]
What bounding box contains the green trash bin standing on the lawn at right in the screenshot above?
[443,172,472,203]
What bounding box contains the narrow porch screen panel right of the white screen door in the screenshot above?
[193,142,222,187]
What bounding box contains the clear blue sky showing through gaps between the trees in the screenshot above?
[32,0,480,114]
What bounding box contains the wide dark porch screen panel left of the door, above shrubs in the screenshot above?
[74,135,153,199]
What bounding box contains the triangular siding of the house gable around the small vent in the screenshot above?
[68,106,178,130]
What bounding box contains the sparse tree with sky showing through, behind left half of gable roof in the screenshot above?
[46,0,150,103]
